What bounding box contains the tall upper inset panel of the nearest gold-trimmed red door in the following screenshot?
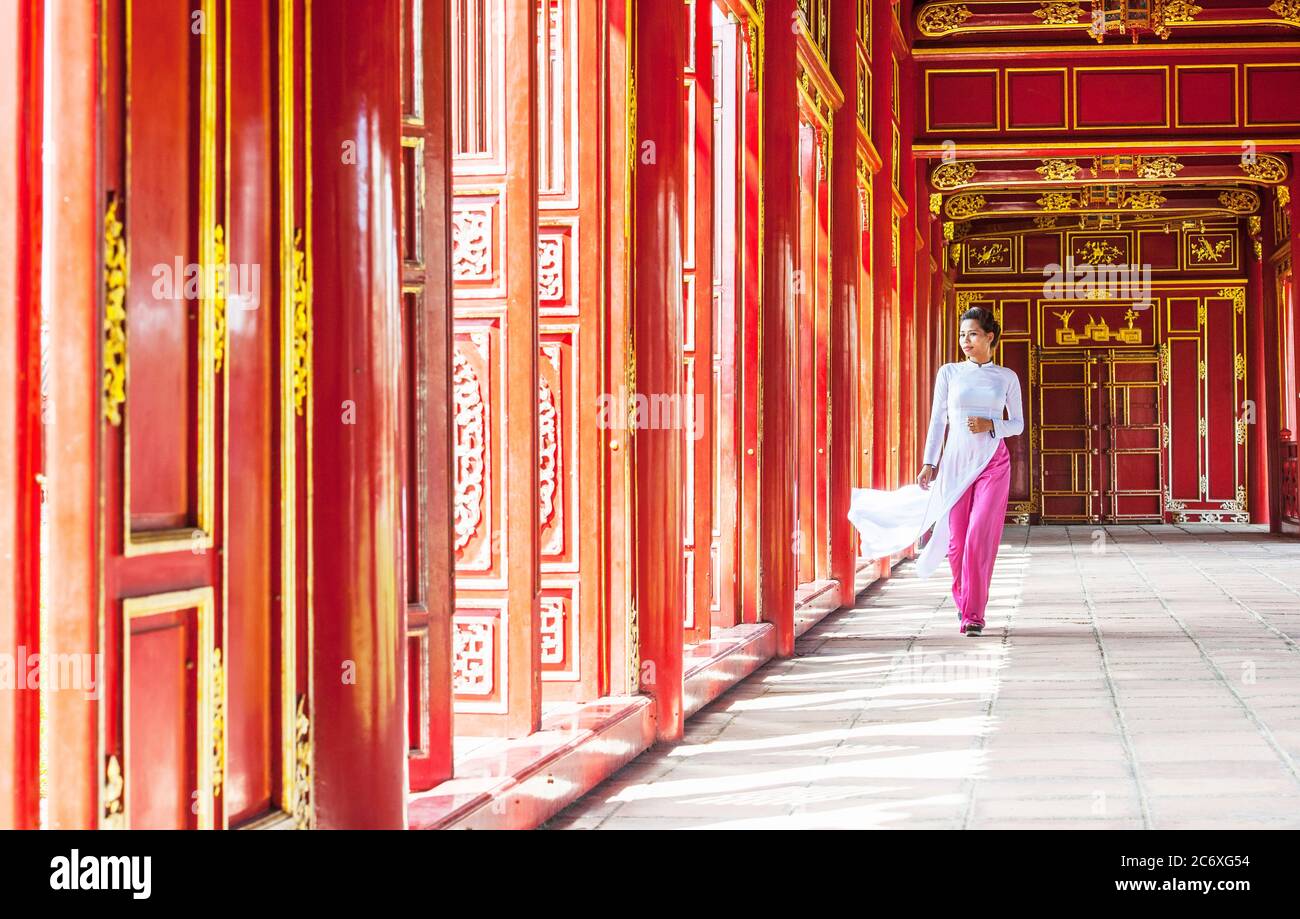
[124,0,212,541]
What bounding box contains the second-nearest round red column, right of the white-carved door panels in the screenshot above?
[631,3,690,740]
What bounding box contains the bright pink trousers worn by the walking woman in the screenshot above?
[948,441,1011,632]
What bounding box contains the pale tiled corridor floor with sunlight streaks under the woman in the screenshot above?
[547,524,1300,829]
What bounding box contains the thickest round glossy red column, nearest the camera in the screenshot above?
[308,0,407,828]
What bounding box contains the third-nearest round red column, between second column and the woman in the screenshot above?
[758,0,800,658]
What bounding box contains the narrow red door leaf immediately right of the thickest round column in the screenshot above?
[399,0,454,790]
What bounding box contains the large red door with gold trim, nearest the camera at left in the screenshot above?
[100,0,311,828]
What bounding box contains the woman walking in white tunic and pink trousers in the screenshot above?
[849,307,1024,636]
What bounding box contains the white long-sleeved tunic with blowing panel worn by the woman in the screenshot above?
[849,360,1024,577]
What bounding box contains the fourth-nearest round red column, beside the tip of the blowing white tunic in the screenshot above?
[829,8,862,604]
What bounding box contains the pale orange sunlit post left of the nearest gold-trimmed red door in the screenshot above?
[41,3,104,829]
